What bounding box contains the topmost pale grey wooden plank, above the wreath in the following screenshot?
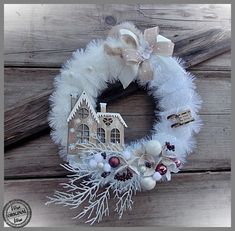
[4,4,231,67]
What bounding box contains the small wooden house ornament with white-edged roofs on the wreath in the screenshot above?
[67,91,127,155]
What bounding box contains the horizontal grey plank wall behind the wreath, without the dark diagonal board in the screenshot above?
[4,4,232,227]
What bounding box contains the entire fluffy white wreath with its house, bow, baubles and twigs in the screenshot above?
[47,23,202,224]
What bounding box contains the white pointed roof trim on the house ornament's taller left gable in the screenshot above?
[67,91,99,123]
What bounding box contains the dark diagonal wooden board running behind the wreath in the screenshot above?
[4,7,231,146]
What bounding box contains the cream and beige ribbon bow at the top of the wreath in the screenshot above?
[119,27,174,88]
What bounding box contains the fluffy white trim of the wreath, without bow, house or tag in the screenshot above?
[49,23,202,164]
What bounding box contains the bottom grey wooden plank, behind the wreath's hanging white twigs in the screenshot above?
[5,172,231,227]
